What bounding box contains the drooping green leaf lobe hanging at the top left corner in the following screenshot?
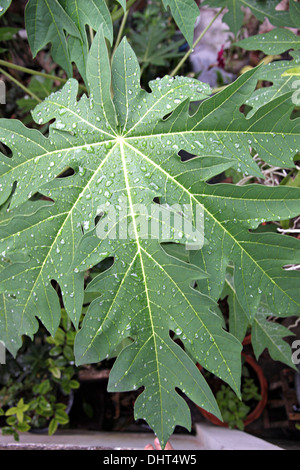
[25,0,80,77]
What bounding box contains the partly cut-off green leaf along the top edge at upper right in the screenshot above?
[204,0,290,35]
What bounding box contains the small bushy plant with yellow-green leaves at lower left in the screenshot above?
[0,311,79,440]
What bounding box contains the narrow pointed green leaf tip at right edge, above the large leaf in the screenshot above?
[236,28,300,55]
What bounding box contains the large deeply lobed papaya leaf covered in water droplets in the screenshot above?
[0,30,300,445]
